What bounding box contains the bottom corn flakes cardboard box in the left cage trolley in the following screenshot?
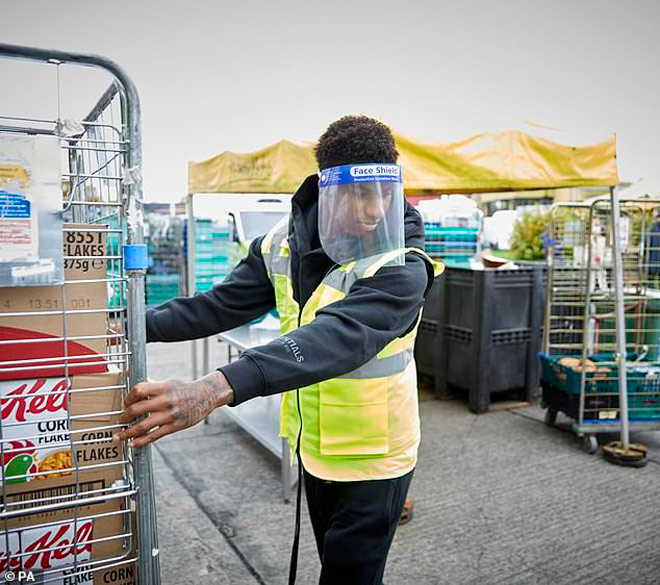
[0,499,137,585]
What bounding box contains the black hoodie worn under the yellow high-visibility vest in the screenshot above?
[147,175,433,405]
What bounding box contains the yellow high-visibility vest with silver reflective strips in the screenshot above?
[261,218,444,481]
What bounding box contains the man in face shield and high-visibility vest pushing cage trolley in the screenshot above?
[118,116,440,585]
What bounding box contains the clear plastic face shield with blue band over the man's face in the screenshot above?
[319,164,405,265]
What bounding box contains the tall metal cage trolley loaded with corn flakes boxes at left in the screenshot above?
[0,44,160,585]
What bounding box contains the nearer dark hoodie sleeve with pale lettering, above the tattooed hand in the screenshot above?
[219,253,433,406]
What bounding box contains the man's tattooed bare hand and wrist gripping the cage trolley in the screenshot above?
[112,372,234,447]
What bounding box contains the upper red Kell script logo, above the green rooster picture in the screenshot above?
[0,378,68,422]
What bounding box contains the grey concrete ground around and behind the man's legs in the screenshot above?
[148,343,660,585]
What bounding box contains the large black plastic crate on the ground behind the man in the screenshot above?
[415,265,546,413]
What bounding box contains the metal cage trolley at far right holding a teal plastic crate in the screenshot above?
[541,197,660,453]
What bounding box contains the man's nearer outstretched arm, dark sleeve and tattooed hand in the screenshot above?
[113,254,433,447]
